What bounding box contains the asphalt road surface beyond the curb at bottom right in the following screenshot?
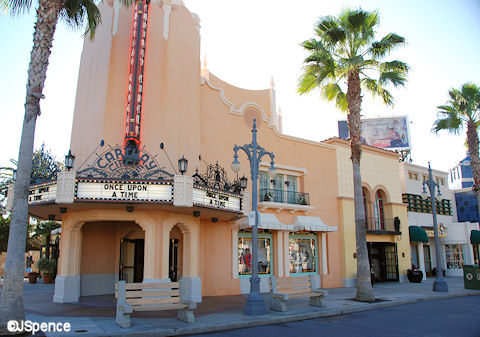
[191,296,480,337]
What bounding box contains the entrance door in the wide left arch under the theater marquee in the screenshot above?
[119,239,145,283]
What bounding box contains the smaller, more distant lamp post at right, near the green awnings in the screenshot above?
[423,162,448,292]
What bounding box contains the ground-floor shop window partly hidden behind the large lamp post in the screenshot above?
[238,231,272,275]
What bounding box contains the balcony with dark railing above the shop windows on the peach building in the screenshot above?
[258,188,313,213]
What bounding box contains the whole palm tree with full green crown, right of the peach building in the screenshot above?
[297,9,408,301]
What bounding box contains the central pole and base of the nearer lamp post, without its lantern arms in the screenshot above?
[243,119,267,315]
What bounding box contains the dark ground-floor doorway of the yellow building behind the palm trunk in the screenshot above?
[367,242,398,282]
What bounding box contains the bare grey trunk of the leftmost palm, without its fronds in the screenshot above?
[0,0,62,334]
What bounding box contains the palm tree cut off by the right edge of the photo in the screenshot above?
[432,83,480,210]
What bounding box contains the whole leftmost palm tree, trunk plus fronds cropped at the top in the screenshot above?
[0,0,100,334]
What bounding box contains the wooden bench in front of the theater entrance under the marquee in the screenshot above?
[115,281,197,328]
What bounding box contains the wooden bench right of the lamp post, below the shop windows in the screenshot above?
[269,275,328,312]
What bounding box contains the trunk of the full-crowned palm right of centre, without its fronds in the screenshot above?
[347,71,375,302]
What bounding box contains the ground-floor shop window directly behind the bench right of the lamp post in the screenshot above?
[288,234,317,275]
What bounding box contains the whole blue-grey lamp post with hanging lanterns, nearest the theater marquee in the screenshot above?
[232,119,276,315]
